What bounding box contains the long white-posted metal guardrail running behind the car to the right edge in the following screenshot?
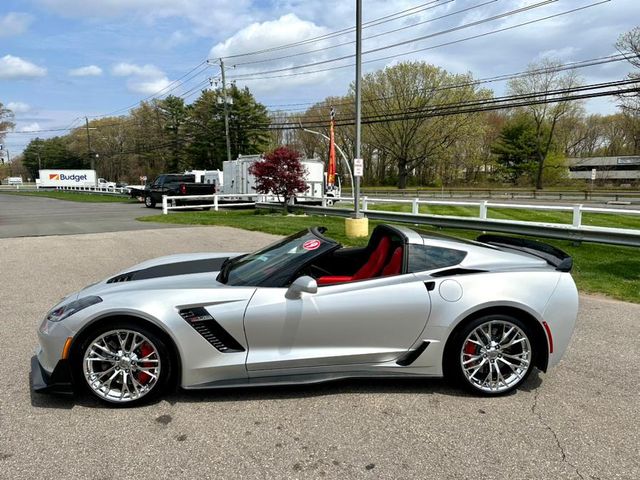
[256,197,640,247]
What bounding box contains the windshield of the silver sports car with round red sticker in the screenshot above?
[218,230,340,287]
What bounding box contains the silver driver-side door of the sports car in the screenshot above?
[245,274,430,376]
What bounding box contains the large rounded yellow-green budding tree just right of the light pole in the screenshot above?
[362,62,491,188]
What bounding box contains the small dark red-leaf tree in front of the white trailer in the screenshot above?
[249,147,307,211]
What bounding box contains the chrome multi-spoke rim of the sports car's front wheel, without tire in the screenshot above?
[82,329,161,403]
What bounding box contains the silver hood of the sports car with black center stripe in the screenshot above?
[78,253,241,297]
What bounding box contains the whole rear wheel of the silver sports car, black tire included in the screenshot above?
[442,314,536,396]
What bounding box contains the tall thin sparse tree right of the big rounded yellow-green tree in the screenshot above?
[509,58,583,189]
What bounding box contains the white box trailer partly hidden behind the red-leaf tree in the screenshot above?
[222,155,332,201]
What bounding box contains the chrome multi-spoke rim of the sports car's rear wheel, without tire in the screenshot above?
[460,320,532,393]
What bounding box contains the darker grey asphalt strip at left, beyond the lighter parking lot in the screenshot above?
[0,194,173,238]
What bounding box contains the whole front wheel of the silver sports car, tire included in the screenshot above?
[75,322,172,406]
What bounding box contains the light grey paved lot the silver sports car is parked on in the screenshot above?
[0,226,640,479]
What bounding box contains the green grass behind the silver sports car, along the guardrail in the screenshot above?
[139,210,640,303]
